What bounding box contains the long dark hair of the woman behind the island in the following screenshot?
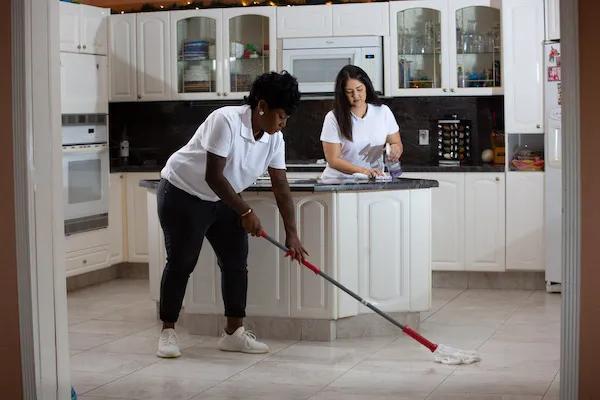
[333,65,382,141]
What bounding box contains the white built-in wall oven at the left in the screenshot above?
[62,114,110,235]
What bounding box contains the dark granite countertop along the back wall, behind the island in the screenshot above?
[116,164,505,173]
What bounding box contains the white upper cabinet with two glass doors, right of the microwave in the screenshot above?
[389,0,503,96]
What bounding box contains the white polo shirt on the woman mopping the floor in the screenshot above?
[161,105,286,201]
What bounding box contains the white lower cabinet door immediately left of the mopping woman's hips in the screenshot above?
[127,172,160,262]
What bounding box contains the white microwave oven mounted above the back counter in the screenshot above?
[282,36,383,94]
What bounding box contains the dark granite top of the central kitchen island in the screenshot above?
[139,178,439,192]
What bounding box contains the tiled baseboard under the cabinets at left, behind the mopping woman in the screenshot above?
[67,263,150,292]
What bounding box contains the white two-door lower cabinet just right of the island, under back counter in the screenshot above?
[402,172,506,271]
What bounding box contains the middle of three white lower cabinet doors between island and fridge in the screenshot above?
[465,172,506,271]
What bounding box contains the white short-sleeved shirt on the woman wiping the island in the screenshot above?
[321,104,400,179]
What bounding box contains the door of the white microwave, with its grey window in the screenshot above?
[283,48,360,93]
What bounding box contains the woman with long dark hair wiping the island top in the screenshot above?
[321,65,403,179]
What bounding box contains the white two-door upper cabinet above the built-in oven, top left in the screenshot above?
[60,1,110,55]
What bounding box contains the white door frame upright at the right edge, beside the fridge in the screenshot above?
[560,0,581,399]
